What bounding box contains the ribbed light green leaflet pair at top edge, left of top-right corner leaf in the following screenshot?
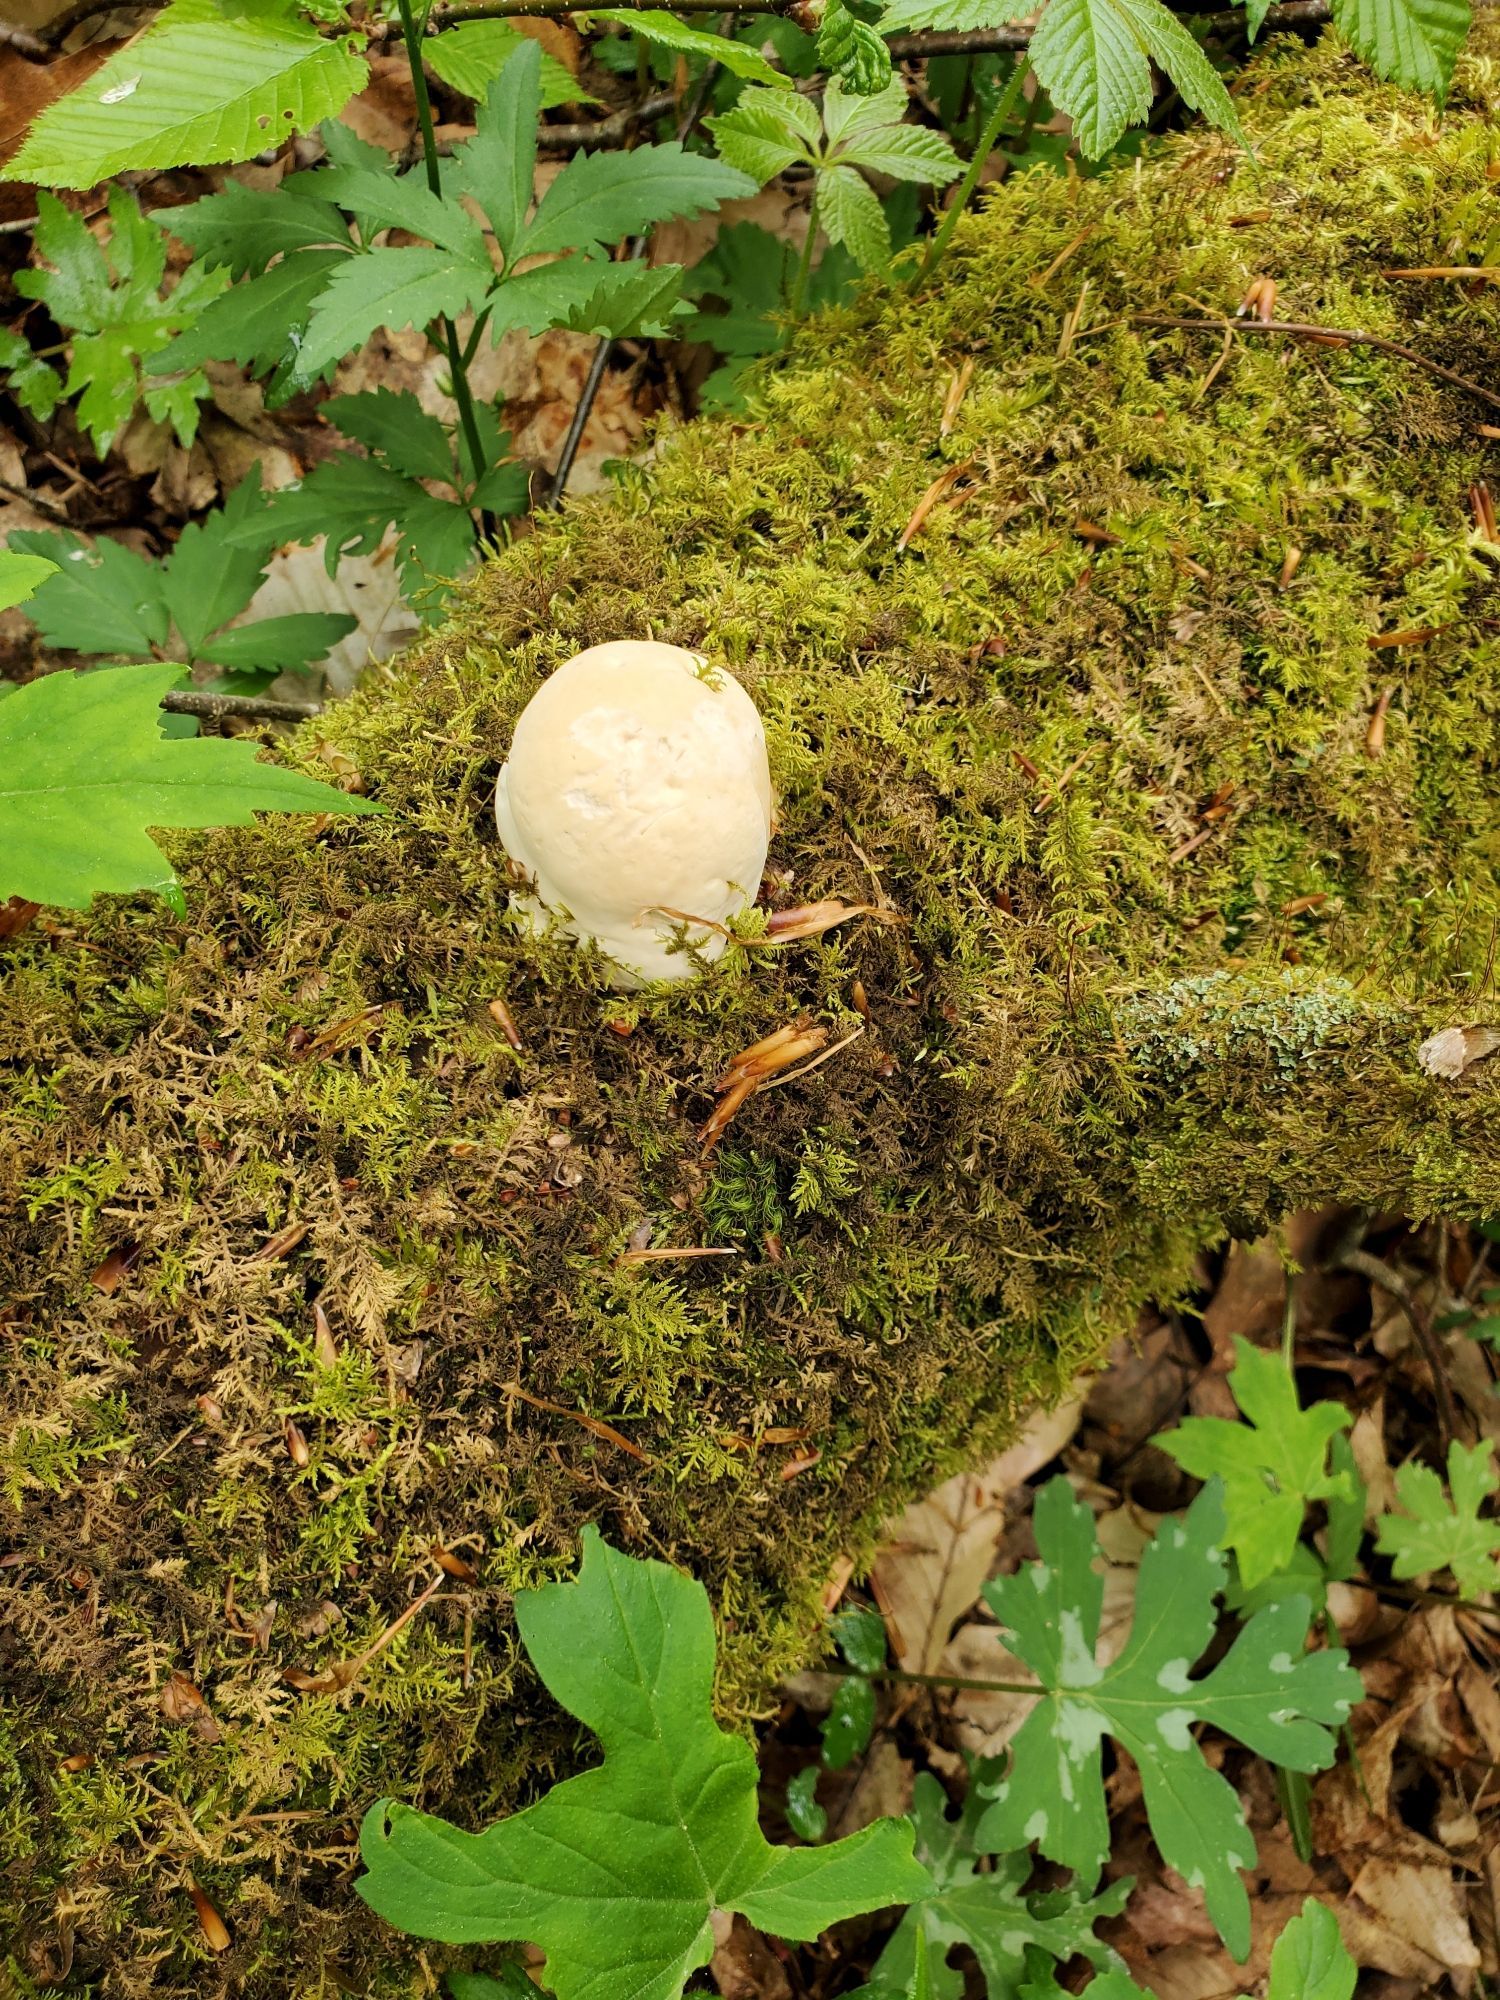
[1030,0,1246,160]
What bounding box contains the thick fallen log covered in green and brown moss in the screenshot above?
[0,40,1500,1996]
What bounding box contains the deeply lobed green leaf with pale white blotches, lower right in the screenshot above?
[978,1478,1360,1958]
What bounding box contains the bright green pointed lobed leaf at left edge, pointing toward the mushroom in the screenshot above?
[0,662,382,910]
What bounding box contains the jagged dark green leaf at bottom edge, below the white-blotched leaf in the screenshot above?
[852,1772,1132,2000]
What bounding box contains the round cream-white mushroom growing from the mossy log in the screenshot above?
[494,640,772,986]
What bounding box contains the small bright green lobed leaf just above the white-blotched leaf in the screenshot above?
[1158,1340,1352,1590]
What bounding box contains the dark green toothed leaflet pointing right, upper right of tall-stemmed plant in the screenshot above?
[514,140,756,256]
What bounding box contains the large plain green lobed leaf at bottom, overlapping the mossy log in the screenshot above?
[356,1528,928,2000]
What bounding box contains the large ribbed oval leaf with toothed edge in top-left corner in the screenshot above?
[0,0,368,188]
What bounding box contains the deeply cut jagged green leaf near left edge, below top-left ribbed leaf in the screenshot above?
[16,188,228,454]
